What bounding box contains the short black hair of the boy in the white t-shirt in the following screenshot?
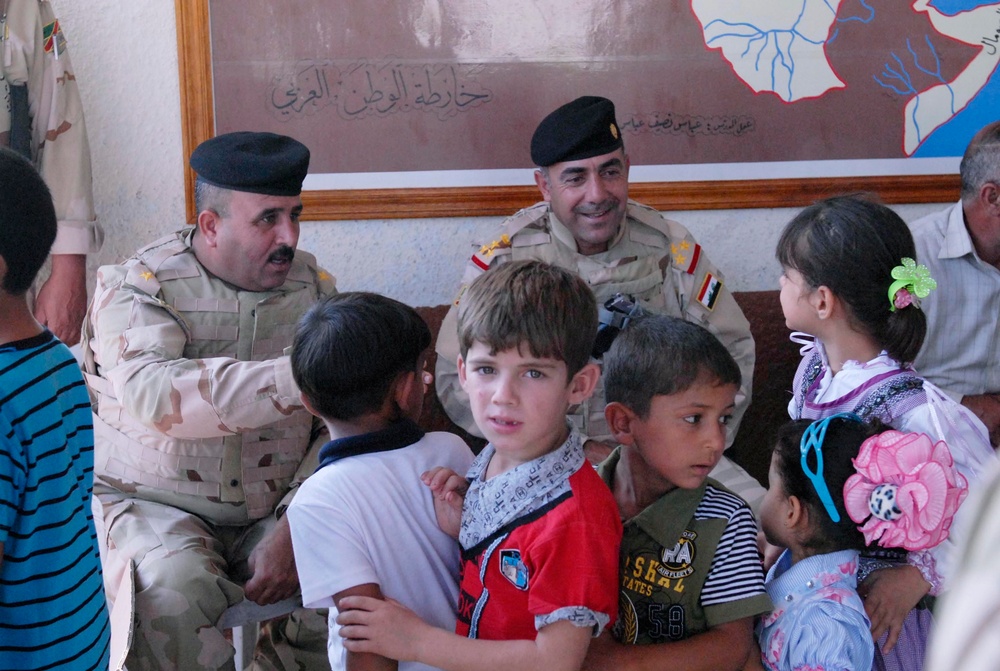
[291,292,431,420]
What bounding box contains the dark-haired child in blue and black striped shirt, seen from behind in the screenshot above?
[0,149,111,670]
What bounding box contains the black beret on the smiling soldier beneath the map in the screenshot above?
[531,96,623,168]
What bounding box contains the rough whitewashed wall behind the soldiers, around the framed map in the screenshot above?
[52,0,943,305]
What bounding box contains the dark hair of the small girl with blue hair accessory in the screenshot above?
[774,417,888,553]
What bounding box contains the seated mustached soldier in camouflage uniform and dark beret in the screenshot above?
[84,133,334,671]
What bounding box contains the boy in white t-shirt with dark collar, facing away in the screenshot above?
[288,293,473,671]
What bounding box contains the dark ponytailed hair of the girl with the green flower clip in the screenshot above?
[777,194,927,363]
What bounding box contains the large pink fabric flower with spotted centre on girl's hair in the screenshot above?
[844,430,968,550]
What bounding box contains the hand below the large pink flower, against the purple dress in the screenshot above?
[858,565,931,653]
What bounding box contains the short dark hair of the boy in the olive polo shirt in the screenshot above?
[604,314,741,418]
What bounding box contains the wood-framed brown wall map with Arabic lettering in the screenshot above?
[176,0,1000,220]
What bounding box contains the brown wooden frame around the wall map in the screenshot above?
[175,0,959,221]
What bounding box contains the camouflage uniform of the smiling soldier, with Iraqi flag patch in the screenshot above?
[436,201,764,508]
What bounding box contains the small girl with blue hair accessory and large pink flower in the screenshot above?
[746,413,967,671]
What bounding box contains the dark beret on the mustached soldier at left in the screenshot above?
[191,131,309,196]
